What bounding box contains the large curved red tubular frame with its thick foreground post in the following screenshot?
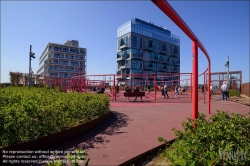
[151,0,211,124]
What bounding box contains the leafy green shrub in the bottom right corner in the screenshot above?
[158,111,250,166]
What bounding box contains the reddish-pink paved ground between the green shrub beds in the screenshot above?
[51,94,250,165]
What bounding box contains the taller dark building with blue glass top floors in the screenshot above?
[117,18,180,85]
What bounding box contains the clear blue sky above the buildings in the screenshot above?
[0,1,250,83]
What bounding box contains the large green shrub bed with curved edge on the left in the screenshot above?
[0,87,109,147]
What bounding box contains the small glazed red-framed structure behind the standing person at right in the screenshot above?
[206,71,242,90]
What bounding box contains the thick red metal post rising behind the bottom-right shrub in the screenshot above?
[192,41,198,127]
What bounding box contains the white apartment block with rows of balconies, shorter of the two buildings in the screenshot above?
[37,40,87,78]
